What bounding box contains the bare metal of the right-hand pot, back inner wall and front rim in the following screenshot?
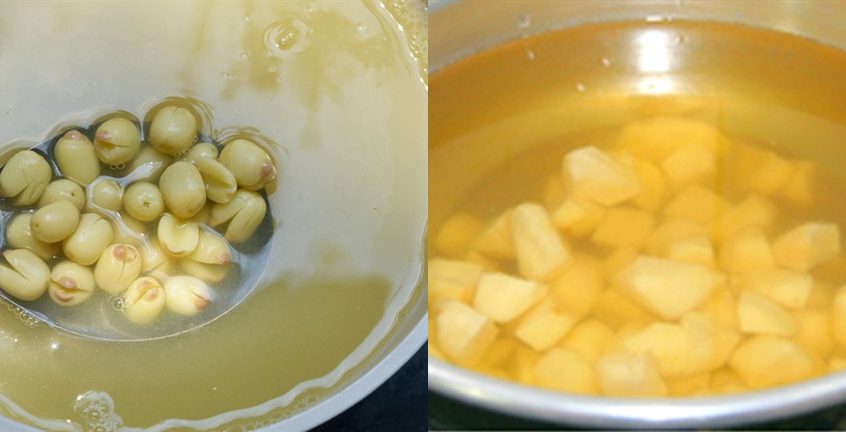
[428,0,846,428]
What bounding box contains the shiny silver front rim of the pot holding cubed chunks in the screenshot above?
[428,357,846,428]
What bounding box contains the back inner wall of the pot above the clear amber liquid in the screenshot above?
[429,0,846,71]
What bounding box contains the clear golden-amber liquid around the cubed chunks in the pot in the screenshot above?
[429,22,846,396]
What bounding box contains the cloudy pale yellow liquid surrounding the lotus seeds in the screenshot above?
[0,1,427,430]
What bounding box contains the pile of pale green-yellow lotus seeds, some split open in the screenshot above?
[0,104,276,324]
